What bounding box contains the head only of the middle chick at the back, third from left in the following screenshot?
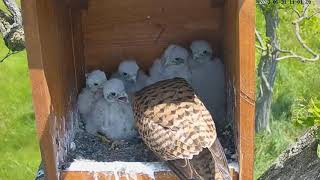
[118,59,139,82]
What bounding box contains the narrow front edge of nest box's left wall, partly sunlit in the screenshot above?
[21,0,57,177]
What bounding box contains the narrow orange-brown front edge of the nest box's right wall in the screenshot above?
[239,0,256,179]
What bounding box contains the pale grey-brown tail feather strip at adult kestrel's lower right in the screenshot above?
[208,138,231,180]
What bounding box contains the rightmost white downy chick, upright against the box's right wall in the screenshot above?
[189,40,226,124]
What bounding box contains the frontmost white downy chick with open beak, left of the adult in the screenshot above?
[86,79,137,141]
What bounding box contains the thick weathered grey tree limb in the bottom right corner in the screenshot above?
[259,127,320,180]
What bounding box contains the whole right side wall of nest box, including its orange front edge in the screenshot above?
[223,0,255,180]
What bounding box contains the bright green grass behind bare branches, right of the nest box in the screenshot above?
[254,2,320,179]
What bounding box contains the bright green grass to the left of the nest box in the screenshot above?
[0,1,40,180]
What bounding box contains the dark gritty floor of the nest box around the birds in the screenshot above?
[60,118,235,172]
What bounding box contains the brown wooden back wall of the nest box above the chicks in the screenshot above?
[83,0,223,71]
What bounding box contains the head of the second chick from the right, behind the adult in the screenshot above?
[162,44,189,66]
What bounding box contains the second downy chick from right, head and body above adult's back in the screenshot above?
[147,44,191,85]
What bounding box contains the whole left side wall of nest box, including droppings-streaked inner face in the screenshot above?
[22,0,81,179]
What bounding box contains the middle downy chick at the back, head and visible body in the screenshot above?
[112,59,148,95]
